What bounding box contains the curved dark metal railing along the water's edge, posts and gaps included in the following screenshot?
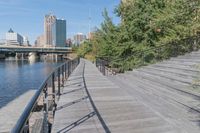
[11,58,80,133]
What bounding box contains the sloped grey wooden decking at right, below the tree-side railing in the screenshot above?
[108,51,200,133]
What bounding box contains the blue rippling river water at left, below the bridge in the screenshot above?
[0,60,61,108]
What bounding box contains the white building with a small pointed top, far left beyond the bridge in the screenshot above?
[6,29,23,45]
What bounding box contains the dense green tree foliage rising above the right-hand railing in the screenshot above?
[76,0,200,71]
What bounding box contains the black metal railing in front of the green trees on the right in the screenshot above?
[96,34,200,75]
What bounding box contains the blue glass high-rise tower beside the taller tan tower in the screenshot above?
[52,19,66,47]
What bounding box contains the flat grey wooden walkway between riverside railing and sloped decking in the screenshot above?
[52,60,186,133]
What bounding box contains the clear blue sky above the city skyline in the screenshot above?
[0,0,120,44]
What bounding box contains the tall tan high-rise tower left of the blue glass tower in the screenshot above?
[44,14,56,47]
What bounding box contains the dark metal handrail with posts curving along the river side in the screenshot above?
[11,58,80,133]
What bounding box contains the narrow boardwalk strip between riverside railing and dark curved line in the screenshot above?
[52,61,110,133]
